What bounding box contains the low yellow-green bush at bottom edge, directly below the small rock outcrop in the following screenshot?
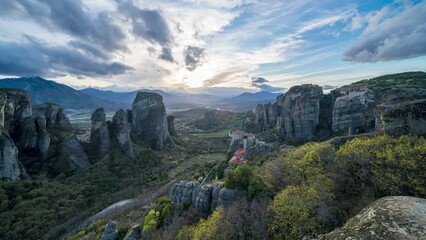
[176,208,229,240]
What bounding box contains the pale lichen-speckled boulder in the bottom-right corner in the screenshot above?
[318,197,426,240]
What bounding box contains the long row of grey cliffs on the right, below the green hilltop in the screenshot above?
[248,72,426,141]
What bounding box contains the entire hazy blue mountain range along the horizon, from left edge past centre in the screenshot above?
[0,77,280,111]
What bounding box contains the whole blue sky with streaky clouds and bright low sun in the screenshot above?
[0,0,426,94]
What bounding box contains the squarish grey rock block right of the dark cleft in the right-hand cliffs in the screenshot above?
[332,90,376,134]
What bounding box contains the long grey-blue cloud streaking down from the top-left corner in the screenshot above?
[0,0,127,52]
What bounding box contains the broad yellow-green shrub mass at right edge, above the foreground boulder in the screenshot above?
[336,135,426,201]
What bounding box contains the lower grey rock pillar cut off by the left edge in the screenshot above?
[0,127,21,181]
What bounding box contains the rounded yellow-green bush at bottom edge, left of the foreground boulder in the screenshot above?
[269,186,320,239]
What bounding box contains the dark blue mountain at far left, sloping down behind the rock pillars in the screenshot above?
[0,77,121,109]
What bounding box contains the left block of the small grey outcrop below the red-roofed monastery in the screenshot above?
[170,181,200,204]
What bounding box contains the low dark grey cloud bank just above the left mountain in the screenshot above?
[0,38,131,77]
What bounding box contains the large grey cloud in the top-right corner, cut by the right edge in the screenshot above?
[344,2,426,62]
